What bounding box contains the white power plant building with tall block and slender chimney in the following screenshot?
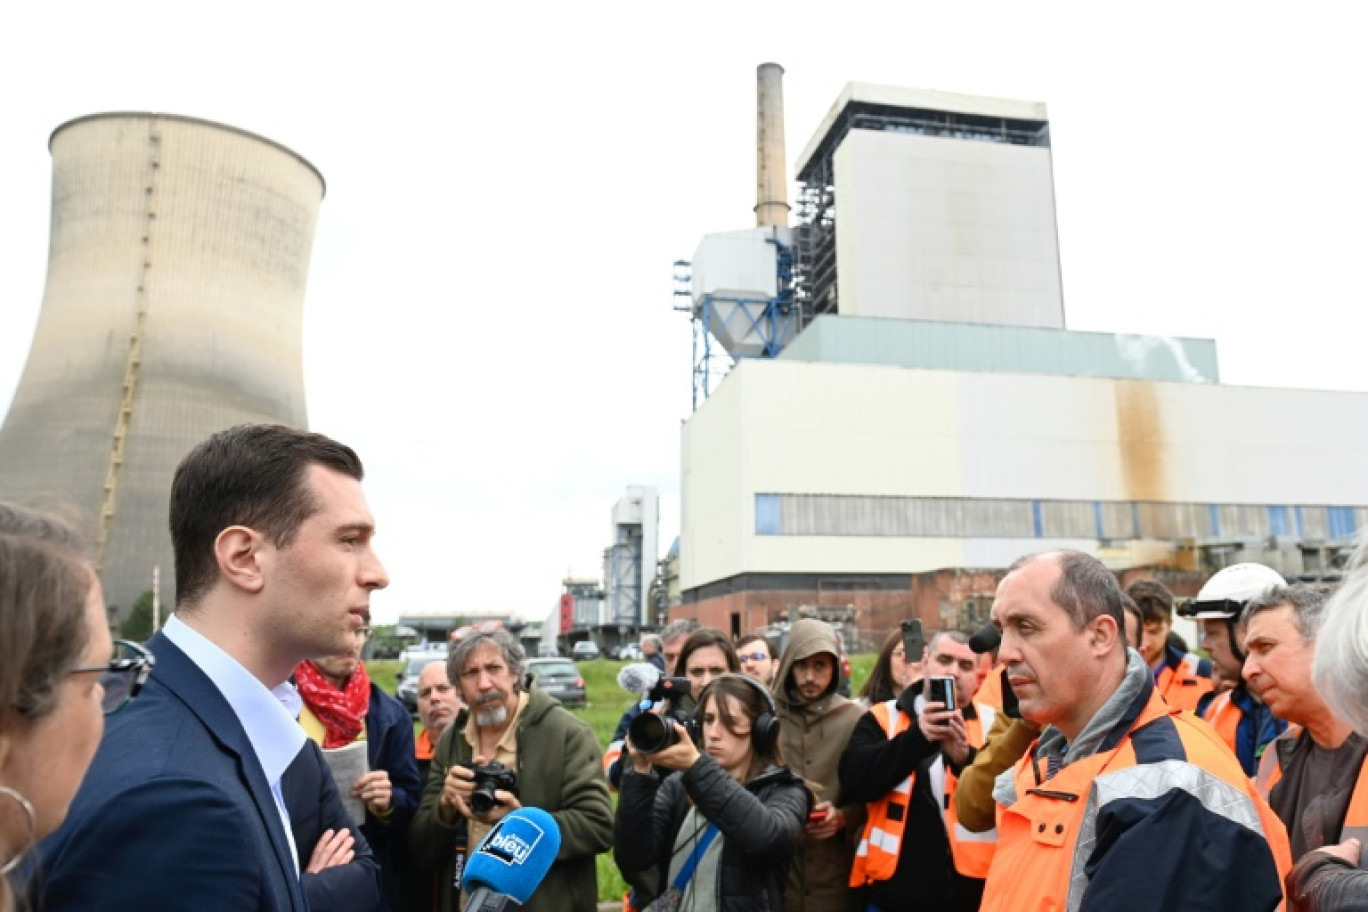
[670,64,1368,645]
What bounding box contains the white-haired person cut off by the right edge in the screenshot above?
[1287,546,1368,912]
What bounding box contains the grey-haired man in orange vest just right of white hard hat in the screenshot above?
[1244,584,1368,859]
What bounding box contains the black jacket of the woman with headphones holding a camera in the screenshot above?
[613,755,811,912]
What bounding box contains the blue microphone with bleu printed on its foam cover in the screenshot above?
[461,808,561,912]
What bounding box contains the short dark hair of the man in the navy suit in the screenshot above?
[171,424,364,606]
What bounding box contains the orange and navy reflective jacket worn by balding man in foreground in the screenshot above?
[979,689,1291,912]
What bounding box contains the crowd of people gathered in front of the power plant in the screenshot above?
[0,425,1368,912]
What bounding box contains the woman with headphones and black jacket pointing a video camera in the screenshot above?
[613,673,811,912]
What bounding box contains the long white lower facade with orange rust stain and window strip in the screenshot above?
[680,360,1368,592]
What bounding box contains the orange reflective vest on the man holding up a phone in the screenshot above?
[850,700,997,887]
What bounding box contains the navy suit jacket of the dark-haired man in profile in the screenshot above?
[33,633,313,912]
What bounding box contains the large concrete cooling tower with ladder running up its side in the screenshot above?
[0,113,324,614]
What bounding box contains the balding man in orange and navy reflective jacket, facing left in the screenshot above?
[982,551,1290,912]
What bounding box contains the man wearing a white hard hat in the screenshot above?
[1178,563,1287,777]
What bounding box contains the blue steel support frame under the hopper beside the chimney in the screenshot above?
[674,238,803,410]
